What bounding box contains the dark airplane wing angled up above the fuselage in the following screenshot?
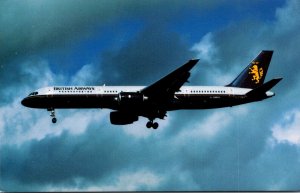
[141,59,199,100]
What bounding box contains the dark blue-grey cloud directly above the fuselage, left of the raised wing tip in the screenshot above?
[99,25,191,85]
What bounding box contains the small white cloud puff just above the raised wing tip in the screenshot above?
[191,32,218,63]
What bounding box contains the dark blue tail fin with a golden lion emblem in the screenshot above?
[227,50,273,89]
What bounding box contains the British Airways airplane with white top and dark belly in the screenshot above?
[21,50,282,129]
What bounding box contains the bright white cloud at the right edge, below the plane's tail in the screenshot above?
[271,109,300,145]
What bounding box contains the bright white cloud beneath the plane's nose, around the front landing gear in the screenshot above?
[0,93,108,145]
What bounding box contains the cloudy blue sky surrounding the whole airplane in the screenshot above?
[0,0,300,191]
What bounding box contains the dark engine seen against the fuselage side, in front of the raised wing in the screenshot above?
[118,92,148,107]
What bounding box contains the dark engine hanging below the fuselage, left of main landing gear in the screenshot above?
[110,111,139,125]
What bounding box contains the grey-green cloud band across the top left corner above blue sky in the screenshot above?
[0,0,216,62]
